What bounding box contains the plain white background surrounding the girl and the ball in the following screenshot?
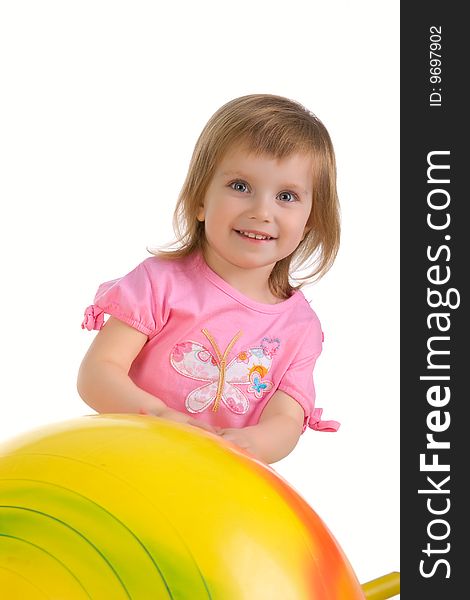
[0,0,400,583]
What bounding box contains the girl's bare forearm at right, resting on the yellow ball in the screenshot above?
[221,390,304,464]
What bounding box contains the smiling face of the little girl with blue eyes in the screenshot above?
[197,147,313,274]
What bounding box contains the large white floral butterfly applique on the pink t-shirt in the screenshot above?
[170,329,273,415]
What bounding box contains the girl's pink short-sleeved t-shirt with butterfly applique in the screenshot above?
[82,253,339,431]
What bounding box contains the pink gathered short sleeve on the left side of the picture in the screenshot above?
[82,261,158,337]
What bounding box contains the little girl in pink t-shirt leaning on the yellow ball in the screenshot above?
[78,94,340,463]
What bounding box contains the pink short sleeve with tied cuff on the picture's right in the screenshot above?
[278,321,340,433]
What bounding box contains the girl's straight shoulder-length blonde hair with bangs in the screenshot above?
[150,94,340,299]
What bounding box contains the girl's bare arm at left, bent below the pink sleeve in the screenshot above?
[77,317,214,431]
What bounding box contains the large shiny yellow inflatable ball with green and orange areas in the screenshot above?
[0,415,364,600]
